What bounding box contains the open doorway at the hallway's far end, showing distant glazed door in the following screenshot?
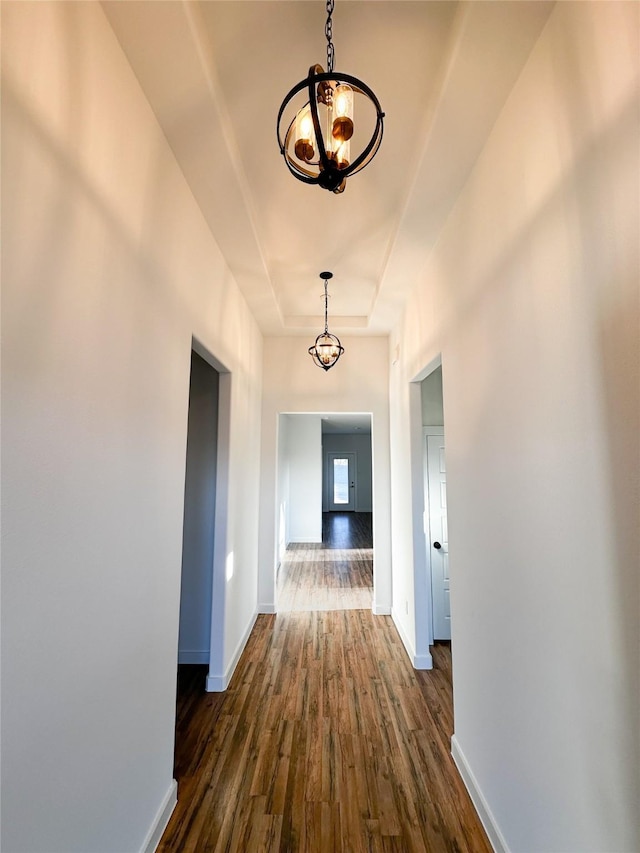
[275,413,374,612]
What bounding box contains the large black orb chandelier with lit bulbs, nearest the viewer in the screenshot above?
[277,0,384,193]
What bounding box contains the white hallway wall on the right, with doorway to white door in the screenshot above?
[391,2,640,853]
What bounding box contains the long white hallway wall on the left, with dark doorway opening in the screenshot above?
[1,2,262,853]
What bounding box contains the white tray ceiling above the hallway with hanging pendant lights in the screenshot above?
[102,0,553,336]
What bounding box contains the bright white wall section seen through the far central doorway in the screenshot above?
[287,415,322,544]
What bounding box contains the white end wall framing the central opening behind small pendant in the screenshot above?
[259,336,391,613]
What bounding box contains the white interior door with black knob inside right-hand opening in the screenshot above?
[427,435,451,640]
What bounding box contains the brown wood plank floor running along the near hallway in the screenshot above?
[158,516,491,853]
